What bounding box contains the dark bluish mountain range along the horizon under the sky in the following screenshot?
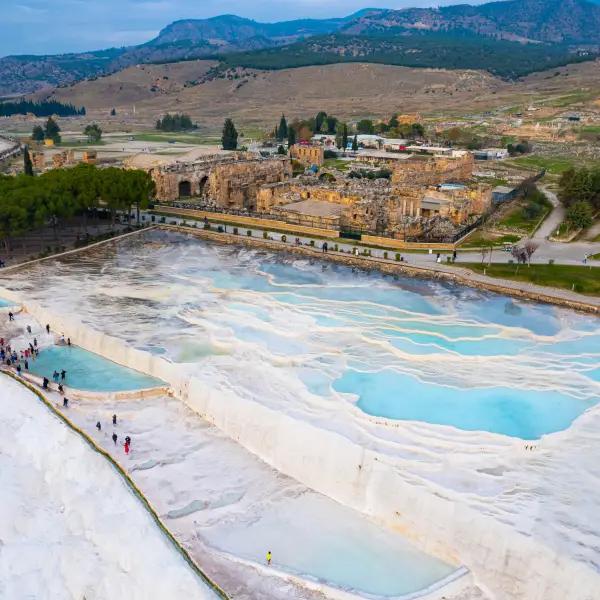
[0,0,600,95]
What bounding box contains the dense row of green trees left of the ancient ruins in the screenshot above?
[0,165,154,249]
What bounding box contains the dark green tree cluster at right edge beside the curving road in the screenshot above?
[558,167,600,229]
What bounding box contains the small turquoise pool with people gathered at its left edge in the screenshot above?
[29,346,164,392]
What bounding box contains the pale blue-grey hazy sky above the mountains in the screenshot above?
[0,0,492,56]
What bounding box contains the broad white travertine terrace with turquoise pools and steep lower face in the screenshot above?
[0,231,600,600]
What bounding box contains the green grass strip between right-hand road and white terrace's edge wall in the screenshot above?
[461,263,600,296]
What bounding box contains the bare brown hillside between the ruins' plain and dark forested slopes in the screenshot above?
[34,61,600,131]
